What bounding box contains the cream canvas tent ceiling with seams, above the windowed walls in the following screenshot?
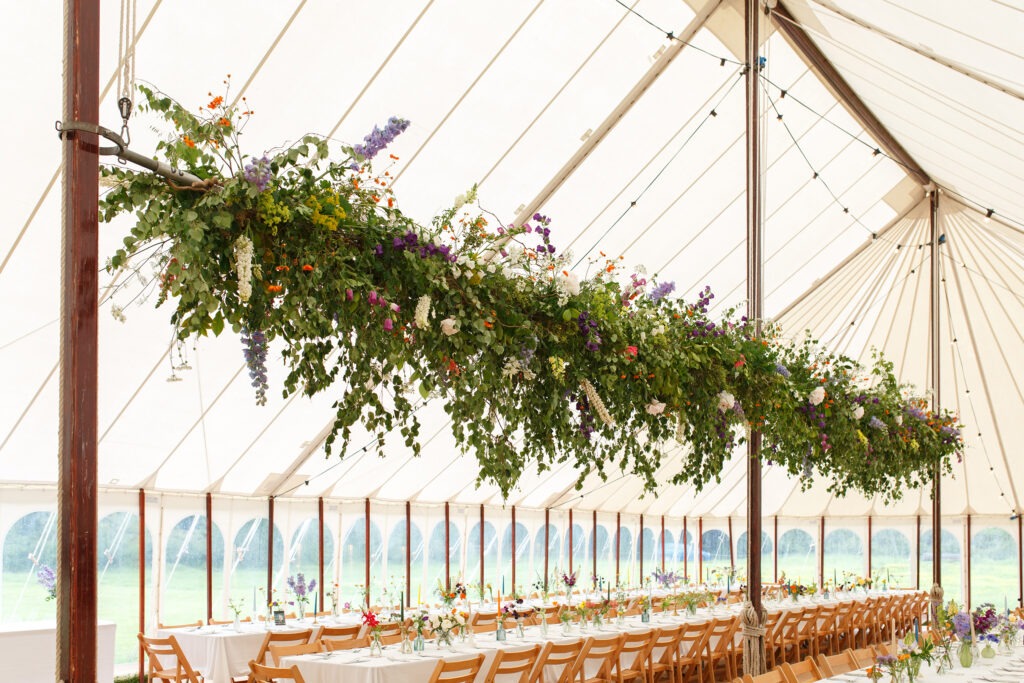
[0,0,1024,516]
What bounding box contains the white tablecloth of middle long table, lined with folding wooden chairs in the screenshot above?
[282,591,929,683]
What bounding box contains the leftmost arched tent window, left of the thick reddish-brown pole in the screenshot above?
[0,512,57,622]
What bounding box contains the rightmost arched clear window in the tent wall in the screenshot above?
[966,516,1020,611]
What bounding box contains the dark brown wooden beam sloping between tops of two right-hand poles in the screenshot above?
[771,2,932,185]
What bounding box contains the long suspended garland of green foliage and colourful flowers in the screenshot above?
[100,88,962,500]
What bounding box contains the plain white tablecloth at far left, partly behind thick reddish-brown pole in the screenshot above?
[0,622,117,683]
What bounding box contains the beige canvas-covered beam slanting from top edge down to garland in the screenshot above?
[515,0,723,225]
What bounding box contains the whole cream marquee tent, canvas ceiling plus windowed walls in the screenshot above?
[0,0,1024,661]
